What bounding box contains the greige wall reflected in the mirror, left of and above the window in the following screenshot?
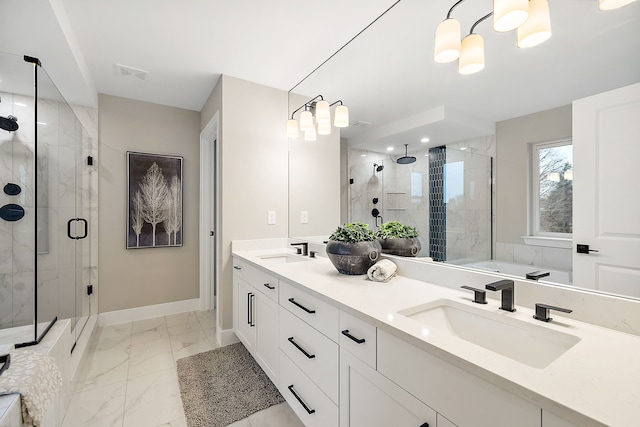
[495,105,571,244]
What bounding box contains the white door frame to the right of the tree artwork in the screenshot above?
[199,112,220,320]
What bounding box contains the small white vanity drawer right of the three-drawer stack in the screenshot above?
[340,311,376,369]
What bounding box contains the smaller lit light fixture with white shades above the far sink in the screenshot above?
[287,95,349,141]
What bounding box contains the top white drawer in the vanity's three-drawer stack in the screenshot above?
[280,281,339,342]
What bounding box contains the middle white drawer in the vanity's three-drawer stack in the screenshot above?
[279,307,340,404]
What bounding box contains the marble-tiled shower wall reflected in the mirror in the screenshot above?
[348,136,495,260]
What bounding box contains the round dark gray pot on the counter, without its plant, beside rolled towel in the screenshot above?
[326,240,382,275]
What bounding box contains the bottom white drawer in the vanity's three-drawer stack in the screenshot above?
[278,350,339,427]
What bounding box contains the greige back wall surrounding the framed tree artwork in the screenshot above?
[98,95,200,313]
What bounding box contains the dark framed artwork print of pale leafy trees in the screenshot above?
[127,152,183,249]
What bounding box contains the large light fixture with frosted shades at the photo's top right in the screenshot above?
[433,0,636,74]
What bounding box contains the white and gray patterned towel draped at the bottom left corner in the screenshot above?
[0,350,62,427]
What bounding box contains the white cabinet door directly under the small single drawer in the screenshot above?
[340,348,436,427]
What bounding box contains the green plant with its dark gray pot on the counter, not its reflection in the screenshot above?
[326,222,382,275]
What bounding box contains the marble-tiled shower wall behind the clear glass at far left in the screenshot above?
[0,93,98,328]
